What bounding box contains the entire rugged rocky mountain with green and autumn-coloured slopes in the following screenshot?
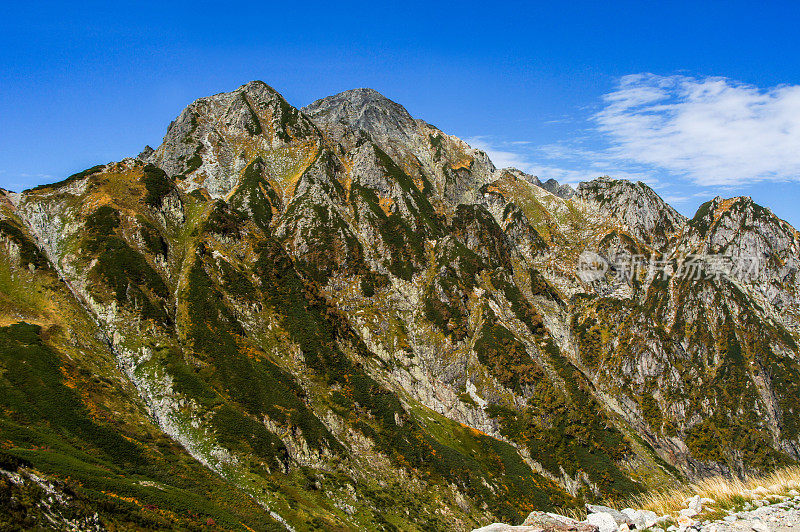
[0,81,800,530]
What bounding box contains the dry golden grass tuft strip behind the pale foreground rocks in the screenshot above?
[614,466,800,515]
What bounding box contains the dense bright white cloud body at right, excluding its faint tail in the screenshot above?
[593,74,800,186]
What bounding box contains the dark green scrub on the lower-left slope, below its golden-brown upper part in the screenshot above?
[0,323,282,530]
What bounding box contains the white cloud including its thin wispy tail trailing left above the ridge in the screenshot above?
[467,74,800,195]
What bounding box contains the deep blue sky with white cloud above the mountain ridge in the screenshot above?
[0,0,800,227]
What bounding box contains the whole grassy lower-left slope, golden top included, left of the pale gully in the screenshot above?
[0,206,284,530]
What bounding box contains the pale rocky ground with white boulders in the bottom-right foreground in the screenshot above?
[473,487,800,532]
